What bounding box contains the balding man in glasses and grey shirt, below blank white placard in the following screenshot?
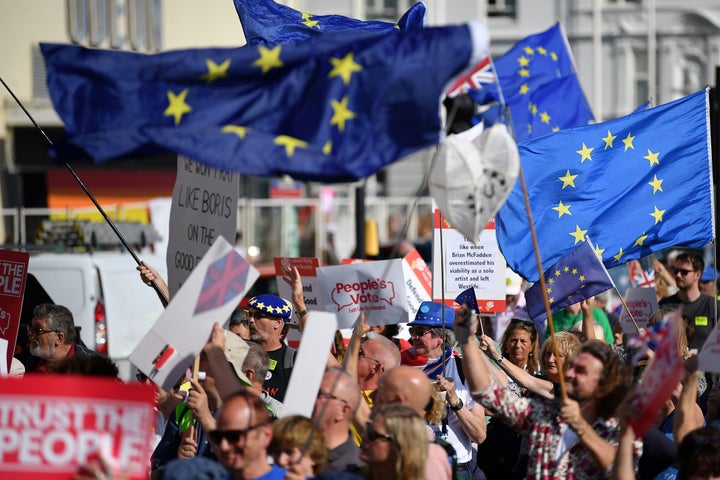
[312,368,362,472]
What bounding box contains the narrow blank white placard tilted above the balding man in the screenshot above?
[282,311,337,418]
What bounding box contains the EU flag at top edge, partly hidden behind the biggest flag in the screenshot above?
[235,0,426,46]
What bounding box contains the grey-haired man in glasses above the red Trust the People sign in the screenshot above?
[26,303,98,373]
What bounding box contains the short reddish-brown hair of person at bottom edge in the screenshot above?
[269,415,328,475]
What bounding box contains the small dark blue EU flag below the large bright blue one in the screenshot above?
[525,239,613,321]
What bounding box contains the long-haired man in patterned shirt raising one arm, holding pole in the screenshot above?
[455,306,642,479]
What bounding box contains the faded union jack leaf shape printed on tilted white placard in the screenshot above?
[194,249,249,315]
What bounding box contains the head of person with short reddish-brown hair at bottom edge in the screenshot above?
[269,415,328,479]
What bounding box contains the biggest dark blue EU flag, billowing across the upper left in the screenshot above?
[41,21,488,182]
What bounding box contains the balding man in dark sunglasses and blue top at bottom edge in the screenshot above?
[209,391,287,480]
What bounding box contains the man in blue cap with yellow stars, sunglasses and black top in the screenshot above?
[245,293,297,402]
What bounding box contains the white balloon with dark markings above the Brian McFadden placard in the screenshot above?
[428,124,520,244]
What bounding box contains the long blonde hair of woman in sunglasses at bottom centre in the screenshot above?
[370,403,429,480]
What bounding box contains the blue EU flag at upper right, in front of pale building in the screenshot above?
[472,23,594,142]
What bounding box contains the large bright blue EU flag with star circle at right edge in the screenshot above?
[496,90,714,281]
